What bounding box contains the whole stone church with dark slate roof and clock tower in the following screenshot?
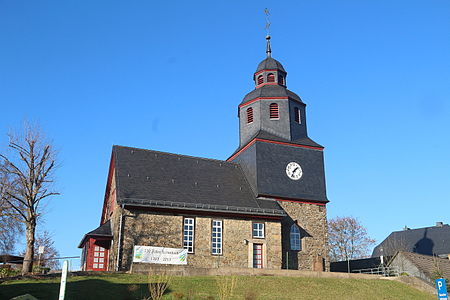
[79,36,329,271]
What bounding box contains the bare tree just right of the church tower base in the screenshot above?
[328,217,375,261]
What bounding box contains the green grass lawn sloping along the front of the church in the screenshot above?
[0,274,435,300]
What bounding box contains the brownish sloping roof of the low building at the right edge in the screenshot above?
[391,251,450,279]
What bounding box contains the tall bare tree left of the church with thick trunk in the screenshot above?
[0,126,58,274]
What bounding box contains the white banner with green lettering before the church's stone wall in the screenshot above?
[133,246,187,265]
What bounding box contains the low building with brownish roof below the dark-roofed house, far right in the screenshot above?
[389,251,450,285]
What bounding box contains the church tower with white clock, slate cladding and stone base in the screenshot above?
[228,36,329,271]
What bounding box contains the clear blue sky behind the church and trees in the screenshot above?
[0,0,450,268]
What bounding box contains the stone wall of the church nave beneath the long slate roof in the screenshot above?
[110,209,281,271]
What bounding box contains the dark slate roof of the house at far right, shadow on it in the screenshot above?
[372,224,450,257]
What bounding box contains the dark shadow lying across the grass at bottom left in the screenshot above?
[0,279,171,300]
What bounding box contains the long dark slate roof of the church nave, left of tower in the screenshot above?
[113,146,285,216]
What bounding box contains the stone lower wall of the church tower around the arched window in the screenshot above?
[278,201,330,271]
